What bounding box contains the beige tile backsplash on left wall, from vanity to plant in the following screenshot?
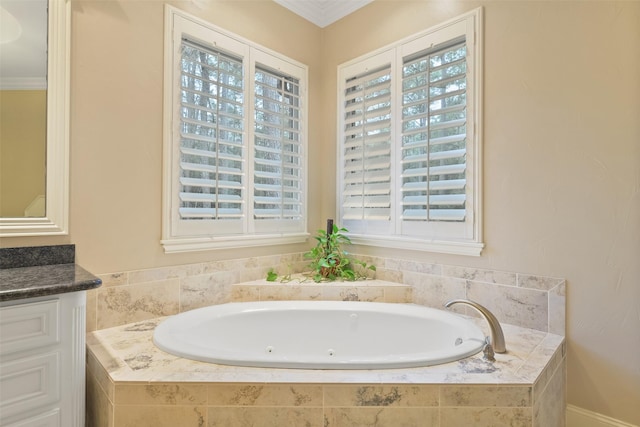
[87,253,306,332]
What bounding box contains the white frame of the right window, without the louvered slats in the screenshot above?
[336,8,484,256]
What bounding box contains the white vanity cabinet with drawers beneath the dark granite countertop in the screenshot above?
[0,291,86,427]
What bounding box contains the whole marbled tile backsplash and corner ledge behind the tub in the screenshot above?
[87,253,565,335]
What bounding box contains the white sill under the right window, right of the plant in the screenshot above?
[348,233,484,256]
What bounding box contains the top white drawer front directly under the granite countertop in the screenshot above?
[0,299,60,356]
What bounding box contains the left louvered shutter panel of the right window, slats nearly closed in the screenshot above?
[342,65,392,221]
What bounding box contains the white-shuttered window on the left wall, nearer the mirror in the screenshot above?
[162,6,307,252]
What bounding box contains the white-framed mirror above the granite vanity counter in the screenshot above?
[0,0,70,237]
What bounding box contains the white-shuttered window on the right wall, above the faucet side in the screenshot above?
[338,9,483,255]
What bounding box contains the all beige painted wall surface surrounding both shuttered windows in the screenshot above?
[2,0,640,424]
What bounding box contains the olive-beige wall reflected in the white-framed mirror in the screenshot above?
[0,90,47,217]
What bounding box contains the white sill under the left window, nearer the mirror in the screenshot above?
[160,232,309,254]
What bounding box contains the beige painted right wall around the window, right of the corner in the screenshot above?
[321,0,640,425]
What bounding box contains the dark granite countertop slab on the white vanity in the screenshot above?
[0,263,102,302]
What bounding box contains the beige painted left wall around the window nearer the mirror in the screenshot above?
[32,0,321,273]
